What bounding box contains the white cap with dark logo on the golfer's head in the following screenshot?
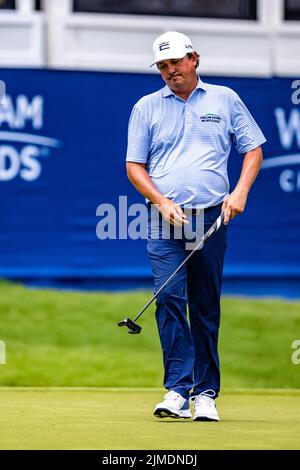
[150,31,195,67]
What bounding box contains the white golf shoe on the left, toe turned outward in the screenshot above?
[154,390,192,418]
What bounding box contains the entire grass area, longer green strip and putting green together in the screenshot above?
[0,282,300,450]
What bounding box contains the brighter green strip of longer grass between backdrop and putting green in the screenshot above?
[0,282,300,390]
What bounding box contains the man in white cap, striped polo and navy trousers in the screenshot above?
[126,31,265,421]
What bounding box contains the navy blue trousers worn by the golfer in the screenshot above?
[147,205,227,398]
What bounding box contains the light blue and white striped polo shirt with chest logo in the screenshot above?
[126,79,266,207]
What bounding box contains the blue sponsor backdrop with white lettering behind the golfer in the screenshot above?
[0,69,300,296]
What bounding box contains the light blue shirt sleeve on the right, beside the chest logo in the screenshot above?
[231,93,266,154]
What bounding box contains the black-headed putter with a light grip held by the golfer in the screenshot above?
[118,212,225,335]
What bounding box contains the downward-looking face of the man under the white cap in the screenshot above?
[156,53,198,92]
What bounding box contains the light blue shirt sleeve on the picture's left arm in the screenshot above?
[126,105,150,163]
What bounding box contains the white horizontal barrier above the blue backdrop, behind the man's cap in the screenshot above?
[0,0,300,77]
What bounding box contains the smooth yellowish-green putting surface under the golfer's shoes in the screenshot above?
[0,388,300,450]
